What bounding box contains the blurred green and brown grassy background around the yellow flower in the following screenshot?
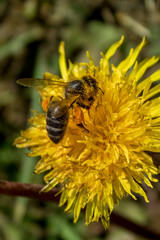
[0,0,160,240]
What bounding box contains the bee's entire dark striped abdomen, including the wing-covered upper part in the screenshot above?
[46,101,69,143]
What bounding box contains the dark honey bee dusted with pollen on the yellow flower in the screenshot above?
[17,76,99,144]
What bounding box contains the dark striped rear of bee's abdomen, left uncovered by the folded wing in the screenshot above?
[46,113,68,143]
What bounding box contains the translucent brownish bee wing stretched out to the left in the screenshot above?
[17,78,66,89]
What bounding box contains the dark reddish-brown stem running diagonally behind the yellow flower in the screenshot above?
[0,180,160,240]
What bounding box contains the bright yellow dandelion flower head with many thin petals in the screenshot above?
[15,37,160,228]
